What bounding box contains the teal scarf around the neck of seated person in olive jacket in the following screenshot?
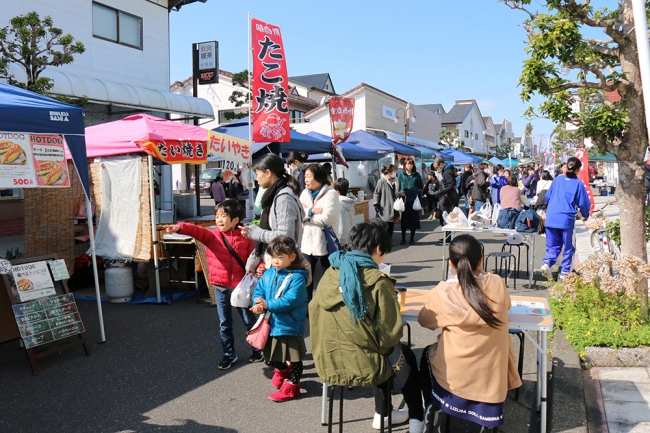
[329,251,379,323]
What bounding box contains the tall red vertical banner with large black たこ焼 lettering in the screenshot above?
[251,19,291,142]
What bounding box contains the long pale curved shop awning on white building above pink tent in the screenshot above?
[42,68,214,119]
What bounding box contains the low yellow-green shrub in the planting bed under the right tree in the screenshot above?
[550,279,650,358]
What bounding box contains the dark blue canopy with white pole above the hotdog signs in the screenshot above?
[0,83,106,341]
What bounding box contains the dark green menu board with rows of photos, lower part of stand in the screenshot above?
[12,293,84,349]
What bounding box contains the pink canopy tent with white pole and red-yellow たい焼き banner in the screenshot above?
[66,114,208,303]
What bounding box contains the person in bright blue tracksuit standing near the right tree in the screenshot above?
[540,157,591,278]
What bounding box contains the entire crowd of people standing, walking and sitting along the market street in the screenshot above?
[158,153,604,433]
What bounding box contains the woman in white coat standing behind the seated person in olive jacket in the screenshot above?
[300,164,341,301]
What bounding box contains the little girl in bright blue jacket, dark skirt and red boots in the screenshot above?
[251,236,309,402]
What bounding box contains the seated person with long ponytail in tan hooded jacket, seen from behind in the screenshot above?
[418,235,521,433]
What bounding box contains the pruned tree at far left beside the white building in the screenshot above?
[0,11,86,98]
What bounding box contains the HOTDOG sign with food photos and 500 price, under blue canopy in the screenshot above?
[0,132,70,188]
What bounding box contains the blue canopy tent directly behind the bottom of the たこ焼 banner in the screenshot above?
[213,117,332,155]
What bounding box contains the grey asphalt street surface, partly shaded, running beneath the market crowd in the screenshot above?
[0,211,586,433]
